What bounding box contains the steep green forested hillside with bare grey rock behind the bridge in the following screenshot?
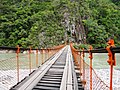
[0,0,120,48]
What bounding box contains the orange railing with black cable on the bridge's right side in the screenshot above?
[70,41,120,90]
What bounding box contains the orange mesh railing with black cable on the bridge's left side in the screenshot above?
[0,45,65,90]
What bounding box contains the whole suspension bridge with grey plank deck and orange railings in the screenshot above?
[0,41,120,90]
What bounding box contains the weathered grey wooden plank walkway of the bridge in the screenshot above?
[10,46,84,90]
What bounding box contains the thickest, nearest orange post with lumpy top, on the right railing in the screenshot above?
[106,39,116,90]
